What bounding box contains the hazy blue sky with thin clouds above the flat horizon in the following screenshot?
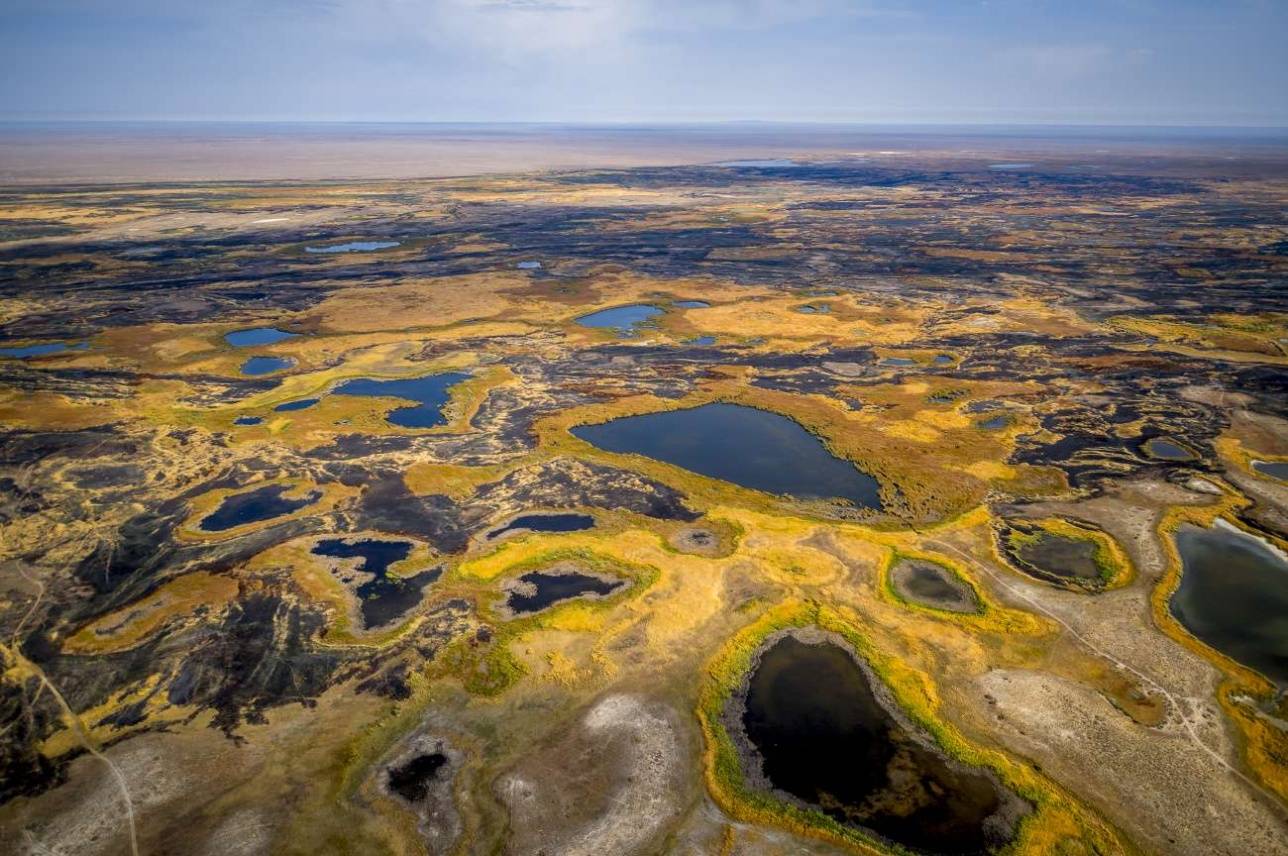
[0,0,1288,126]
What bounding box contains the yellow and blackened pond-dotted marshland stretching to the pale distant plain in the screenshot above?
[0,143,1288,856]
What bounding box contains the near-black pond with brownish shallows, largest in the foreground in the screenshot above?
[742,635,1018,853]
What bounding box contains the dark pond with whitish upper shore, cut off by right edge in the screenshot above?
[1170,524,1288,686]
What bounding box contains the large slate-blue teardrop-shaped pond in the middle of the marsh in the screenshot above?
[572,403,881,508]
